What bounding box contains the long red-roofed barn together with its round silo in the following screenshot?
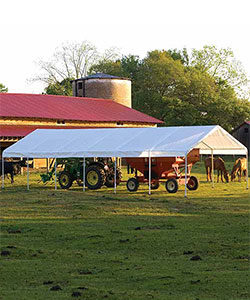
[0,73,162,167]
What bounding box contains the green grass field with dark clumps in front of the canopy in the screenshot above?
[0,163,250,300]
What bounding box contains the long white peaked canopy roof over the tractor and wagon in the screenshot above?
[3,126,247,158]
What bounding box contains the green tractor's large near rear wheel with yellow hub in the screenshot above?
[85,165,106,190]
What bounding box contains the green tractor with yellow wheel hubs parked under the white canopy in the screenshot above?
[41,158,122,190]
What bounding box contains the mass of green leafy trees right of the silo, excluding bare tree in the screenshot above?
[92,47,250,131]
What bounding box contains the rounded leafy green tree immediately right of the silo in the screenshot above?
[134,50,186,121]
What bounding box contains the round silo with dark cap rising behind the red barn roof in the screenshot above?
[72,73,132,107]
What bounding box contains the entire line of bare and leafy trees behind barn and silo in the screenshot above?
[1,41,250,131]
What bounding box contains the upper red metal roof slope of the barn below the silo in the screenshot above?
[0,93,163,124]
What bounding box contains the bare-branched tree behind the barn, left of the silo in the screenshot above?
[32,41,118,94]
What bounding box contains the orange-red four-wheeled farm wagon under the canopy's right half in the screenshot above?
[126,149,199,193]
